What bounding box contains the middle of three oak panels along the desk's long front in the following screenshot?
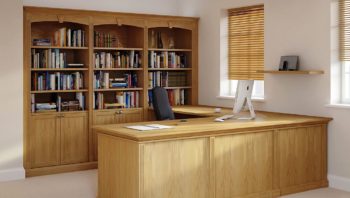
[214,131,273,198]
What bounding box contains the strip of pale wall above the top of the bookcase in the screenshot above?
[23,0,179,15]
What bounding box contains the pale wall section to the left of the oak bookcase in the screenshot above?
[0,0,24,181]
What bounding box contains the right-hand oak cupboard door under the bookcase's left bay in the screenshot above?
[61,113,89,164]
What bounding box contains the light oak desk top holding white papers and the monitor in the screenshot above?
[93,106,332,142]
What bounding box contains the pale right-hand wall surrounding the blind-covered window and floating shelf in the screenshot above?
[194,0,350,191]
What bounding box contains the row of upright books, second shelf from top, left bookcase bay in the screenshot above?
[32,49,68,68]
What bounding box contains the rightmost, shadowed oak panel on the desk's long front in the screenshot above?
[276,126,326,194]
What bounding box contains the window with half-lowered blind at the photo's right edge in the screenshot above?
[339,0,350,104]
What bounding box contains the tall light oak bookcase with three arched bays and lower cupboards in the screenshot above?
[23,7,198,176]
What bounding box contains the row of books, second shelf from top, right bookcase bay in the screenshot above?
[148,51,188,68]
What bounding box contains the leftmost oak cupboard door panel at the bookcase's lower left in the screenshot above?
[29,115,60,168]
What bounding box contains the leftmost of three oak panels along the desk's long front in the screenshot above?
[141,138,210,198]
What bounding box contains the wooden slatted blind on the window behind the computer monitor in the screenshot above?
[228,5,264,80]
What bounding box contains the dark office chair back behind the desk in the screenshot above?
[152,87,175,120]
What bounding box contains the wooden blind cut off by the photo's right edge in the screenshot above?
[339,0,350,61]
